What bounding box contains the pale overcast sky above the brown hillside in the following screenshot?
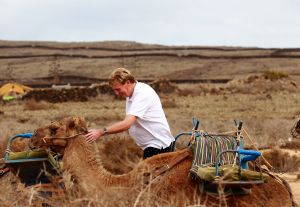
[0,0,300,48]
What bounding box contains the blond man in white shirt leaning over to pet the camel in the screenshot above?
[85,68,174,159]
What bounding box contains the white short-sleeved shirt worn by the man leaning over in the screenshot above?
[126,82,174,149]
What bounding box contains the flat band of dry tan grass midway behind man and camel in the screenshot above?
[0,90,300,146]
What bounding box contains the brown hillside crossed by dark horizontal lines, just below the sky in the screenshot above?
[0,41,300,84]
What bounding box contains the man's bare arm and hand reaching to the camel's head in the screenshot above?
[85,115,137,143]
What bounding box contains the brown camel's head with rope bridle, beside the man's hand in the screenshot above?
[29,117,87,154]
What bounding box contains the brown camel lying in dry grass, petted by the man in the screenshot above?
[30,117,296,207]
